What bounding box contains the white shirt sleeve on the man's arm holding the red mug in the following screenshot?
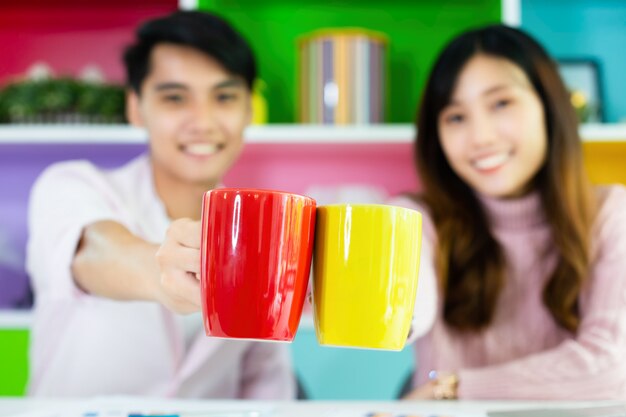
[26,161,121,298]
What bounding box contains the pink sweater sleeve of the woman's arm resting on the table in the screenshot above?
[458,188,626,400]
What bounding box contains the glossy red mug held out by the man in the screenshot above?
[200,188,316,342]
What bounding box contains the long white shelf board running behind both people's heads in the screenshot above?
[0,123,626,145]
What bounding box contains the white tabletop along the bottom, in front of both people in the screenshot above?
[0,397,626,417]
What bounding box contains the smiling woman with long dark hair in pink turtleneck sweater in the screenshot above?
[395,25,626,399]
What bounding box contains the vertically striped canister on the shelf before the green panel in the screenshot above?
[298,28,388,125]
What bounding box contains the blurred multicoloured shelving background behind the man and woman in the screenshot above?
[0,0,626,400]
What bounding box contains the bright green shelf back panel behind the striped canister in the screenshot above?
[198,0,502,123]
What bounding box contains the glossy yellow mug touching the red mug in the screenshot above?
[313,204,422,350]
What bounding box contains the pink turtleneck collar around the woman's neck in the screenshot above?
[477,191,546,229]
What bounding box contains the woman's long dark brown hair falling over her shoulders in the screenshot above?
[415,25,595,332]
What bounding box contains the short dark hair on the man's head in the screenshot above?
[124,11,257,94]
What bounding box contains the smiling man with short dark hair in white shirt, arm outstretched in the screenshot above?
[27,12,295,399]
